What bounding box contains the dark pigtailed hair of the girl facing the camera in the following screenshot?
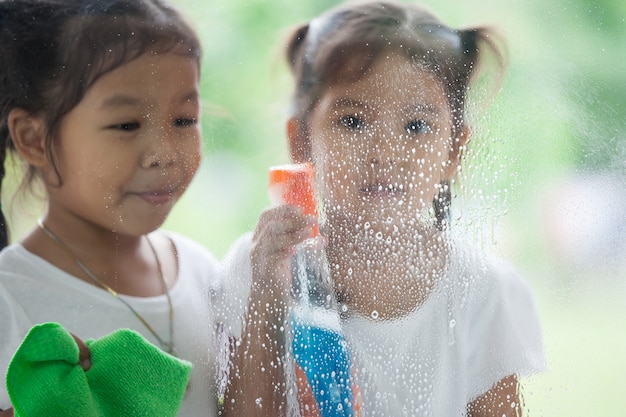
[286,1,504,228]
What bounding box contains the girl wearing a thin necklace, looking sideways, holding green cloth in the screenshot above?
[0,0,309,417]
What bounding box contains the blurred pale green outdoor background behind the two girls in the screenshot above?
[6,0,626,417]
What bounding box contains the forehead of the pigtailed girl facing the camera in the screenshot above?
[318,54,449,114]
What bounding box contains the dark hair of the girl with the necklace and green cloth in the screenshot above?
[0,0,201,248]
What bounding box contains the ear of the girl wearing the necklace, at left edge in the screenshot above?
[7,108,48,168]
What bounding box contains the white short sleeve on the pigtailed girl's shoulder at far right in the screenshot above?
[467,256,545,398]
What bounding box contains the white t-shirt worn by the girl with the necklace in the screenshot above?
[0,232,222,417]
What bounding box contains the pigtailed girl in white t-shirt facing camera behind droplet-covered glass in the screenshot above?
[224,2,543,417]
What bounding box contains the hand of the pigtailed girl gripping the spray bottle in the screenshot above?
[251,205,317,305]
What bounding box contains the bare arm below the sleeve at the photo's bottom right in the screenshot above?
[467,375,522,417]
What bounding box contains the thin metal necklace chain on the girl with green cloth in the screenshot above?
[37,219,174,354]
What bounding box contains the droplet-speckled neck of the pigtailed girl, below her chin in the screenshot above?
[327,224,447,319]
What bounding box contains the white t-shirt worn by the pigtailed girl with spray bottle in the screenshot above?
[225,235,545,417]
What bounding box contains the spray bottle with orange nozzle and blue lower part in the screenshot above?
[269,163,361,417]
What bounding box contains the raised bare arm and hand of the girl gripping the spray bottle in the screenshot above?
[224,206,315,417]
